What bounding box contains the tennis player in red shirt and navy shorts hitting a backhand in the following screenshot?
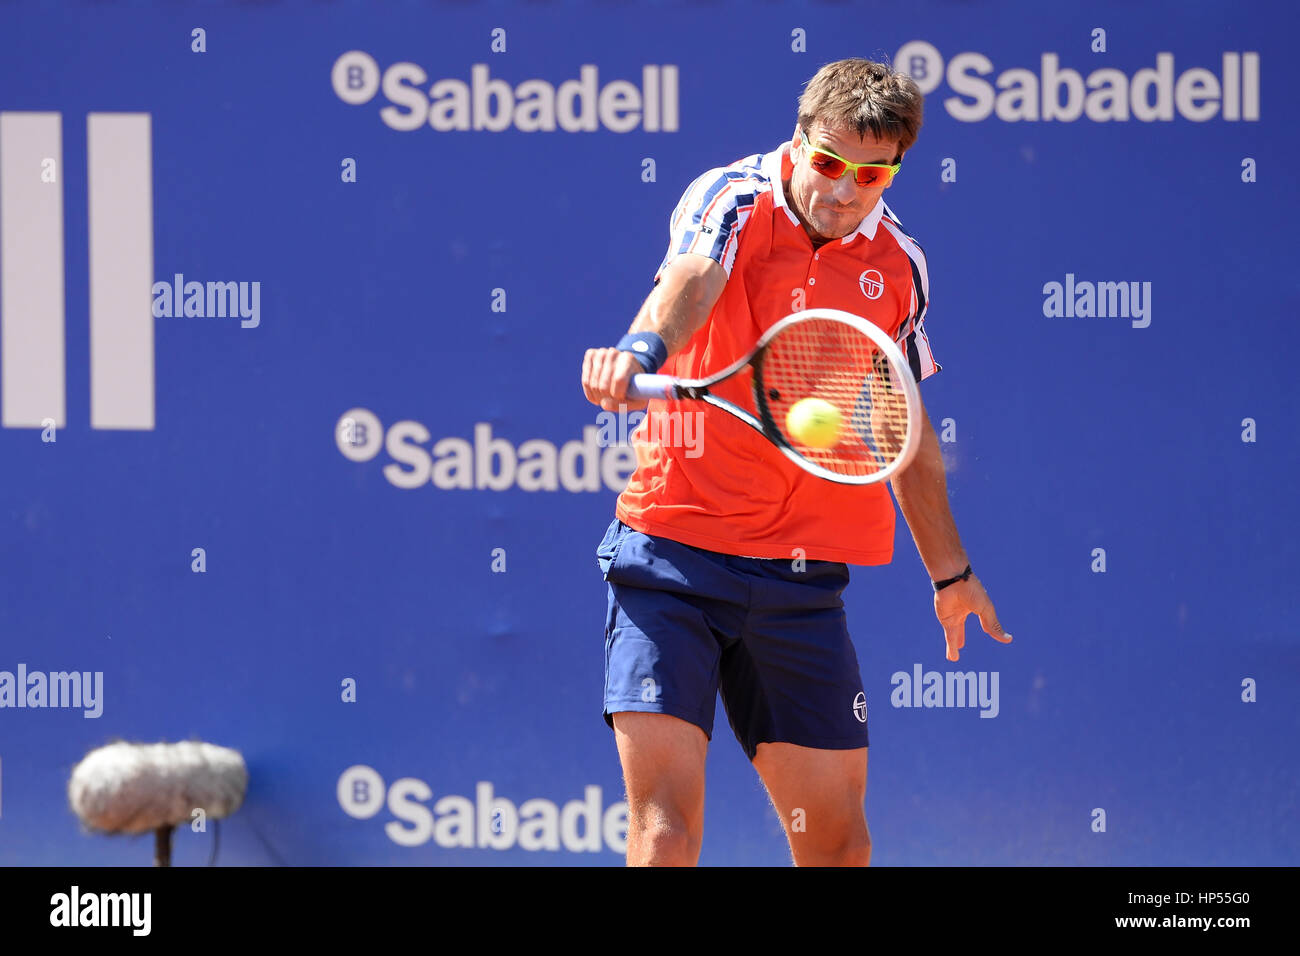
[582,59,1011,866]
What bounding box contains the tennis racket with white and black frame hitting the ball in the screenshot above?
[628,308,920,485]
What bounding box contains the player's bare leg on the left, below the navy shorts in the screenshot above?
[614,711,709,866]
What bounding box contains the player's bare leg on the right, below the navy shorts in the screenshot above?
[754,743,871,866]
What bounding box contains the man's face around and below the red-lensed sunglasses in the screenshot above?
[790,120,898,239]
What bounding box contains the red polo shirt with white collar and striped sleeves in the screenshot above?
[616,143,940,564]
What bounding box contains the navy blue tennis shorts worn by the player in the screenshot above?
[597,519,867,760]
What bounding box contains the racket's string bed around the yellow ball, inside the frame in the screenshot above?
[762,319,909,476]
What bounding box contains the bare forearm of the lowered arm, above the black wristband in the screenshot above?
[889,410,969,581]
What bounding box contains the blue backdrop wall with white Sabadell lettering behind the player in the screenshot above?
[0,0,1300,865]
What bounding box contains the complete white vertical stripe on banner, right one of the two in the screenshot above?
[86,113,153,429]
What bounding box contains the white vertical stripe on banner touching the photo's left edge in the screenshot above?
[0,113,68,428]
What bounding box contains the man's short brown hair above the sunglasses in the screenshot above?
[800,59,924,156]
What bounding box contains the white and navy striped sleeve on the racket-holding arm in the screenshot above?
[654,155,767,282]
